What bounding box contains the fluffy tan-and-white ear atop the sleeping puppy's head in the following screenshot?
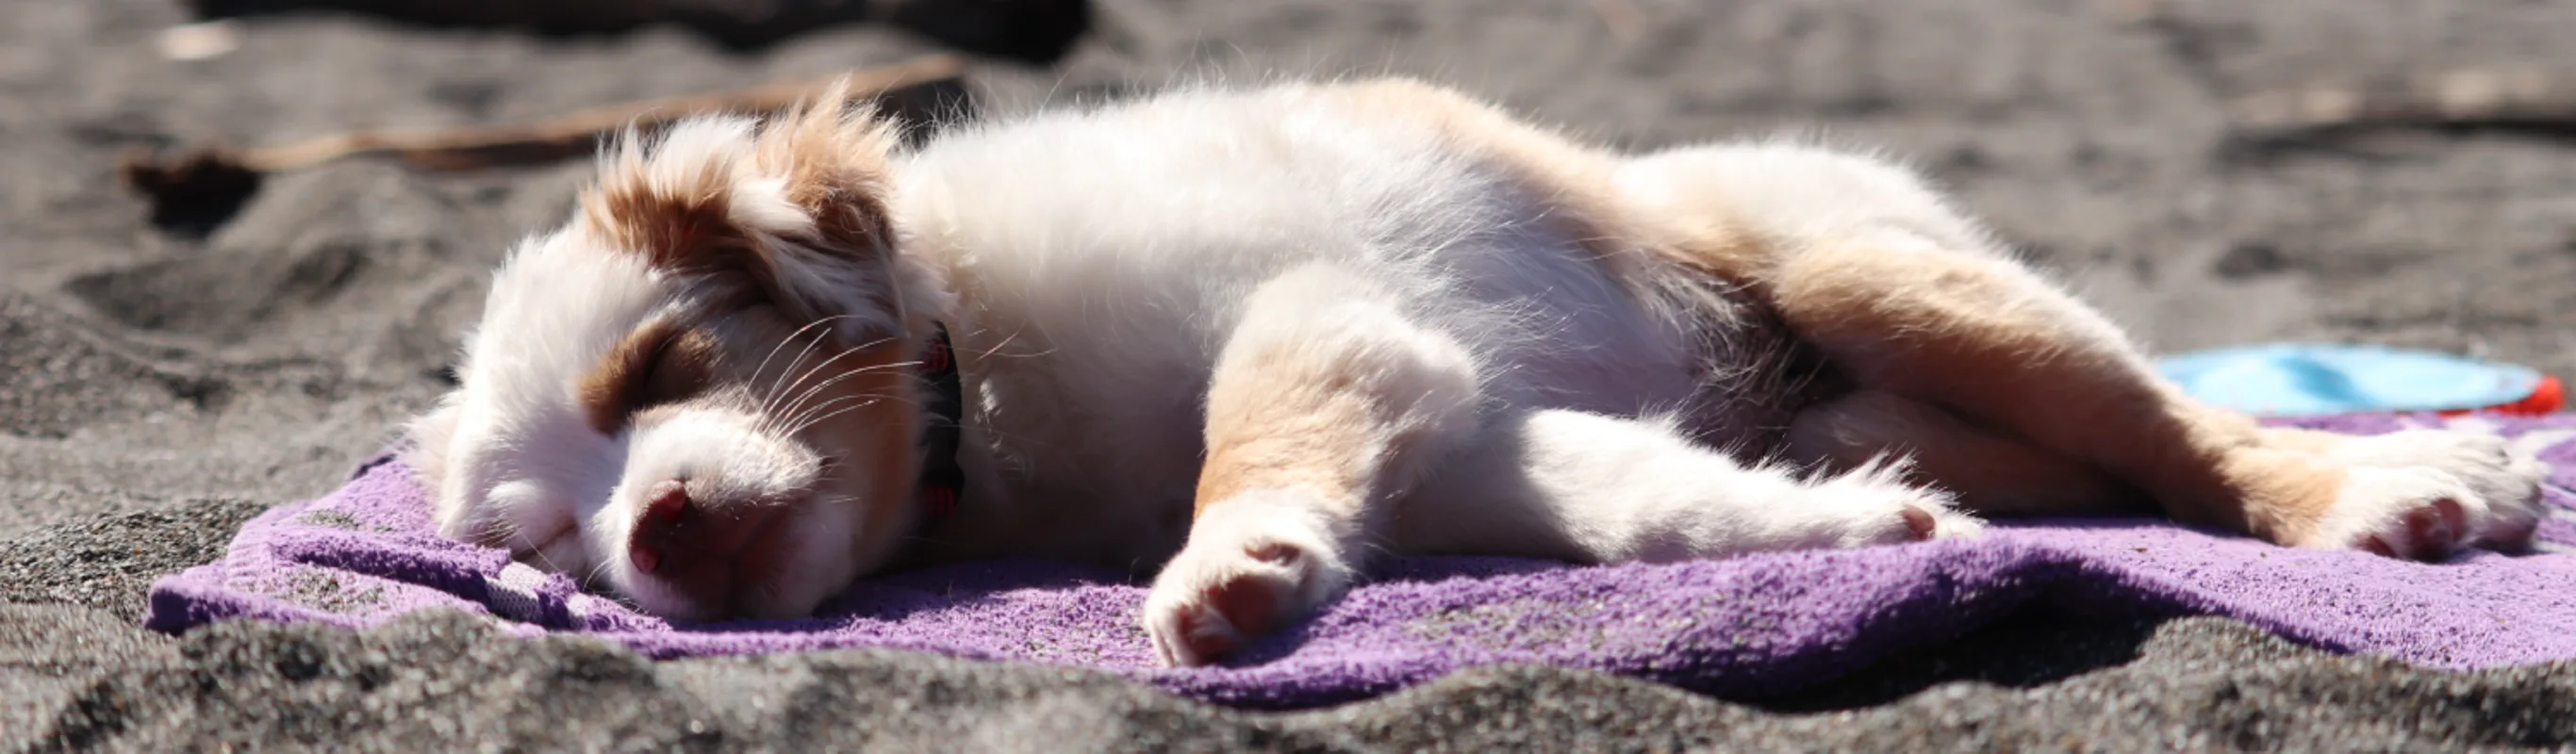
[582,85,904,337]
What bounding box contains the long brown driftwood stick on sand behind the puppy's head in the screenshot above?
[116,54,966,204]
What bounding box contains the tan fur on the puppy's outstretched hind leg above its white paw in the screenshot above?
[1770,238,2344,543]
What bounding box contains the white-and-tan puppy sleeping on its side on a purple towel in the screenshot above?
[412,80,2542,664]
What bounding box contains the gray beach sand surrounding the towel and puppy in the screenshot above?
[0,0,2576,751]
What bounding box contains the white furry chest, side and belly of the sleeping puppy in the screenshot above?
[897,90,1792,571]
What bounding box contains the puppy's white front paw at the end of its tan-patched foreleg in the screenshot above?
[1144,494,1350,666]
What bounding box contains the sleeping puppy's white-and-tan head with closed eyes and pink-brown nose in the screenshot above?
[412,92,930,620]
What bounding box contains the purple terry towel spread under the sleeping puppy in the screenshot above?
[144,415,2576,708]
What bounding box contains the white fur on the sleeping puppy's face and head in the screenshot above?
[412,119,904,615]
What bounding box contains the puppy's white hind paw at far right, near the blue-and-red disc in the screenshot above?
[2305,430,2548,561]
